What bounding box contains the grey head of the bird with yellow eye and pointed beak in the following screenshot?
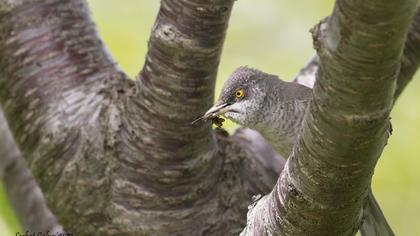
[204,67,274,127]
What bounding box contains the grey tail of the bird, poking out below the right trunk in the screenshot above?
[360,187,395,236]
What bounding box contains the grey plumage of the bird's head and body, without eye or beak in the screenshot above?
[219,67,312,157]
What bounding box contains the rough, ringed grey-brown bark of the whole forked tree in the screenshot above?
[0,0,420,235]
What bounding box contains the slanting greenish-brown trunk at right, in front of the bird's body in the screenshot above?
[242,0,416,235]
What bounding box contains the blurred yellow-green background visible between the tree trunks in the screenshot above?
[0,0,420,235]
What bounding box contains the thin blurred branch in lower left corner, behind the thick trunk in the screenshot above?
[0,109,64,233]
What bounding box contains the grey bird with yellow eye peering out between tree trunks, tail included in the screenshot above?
[202,67,394,236]
